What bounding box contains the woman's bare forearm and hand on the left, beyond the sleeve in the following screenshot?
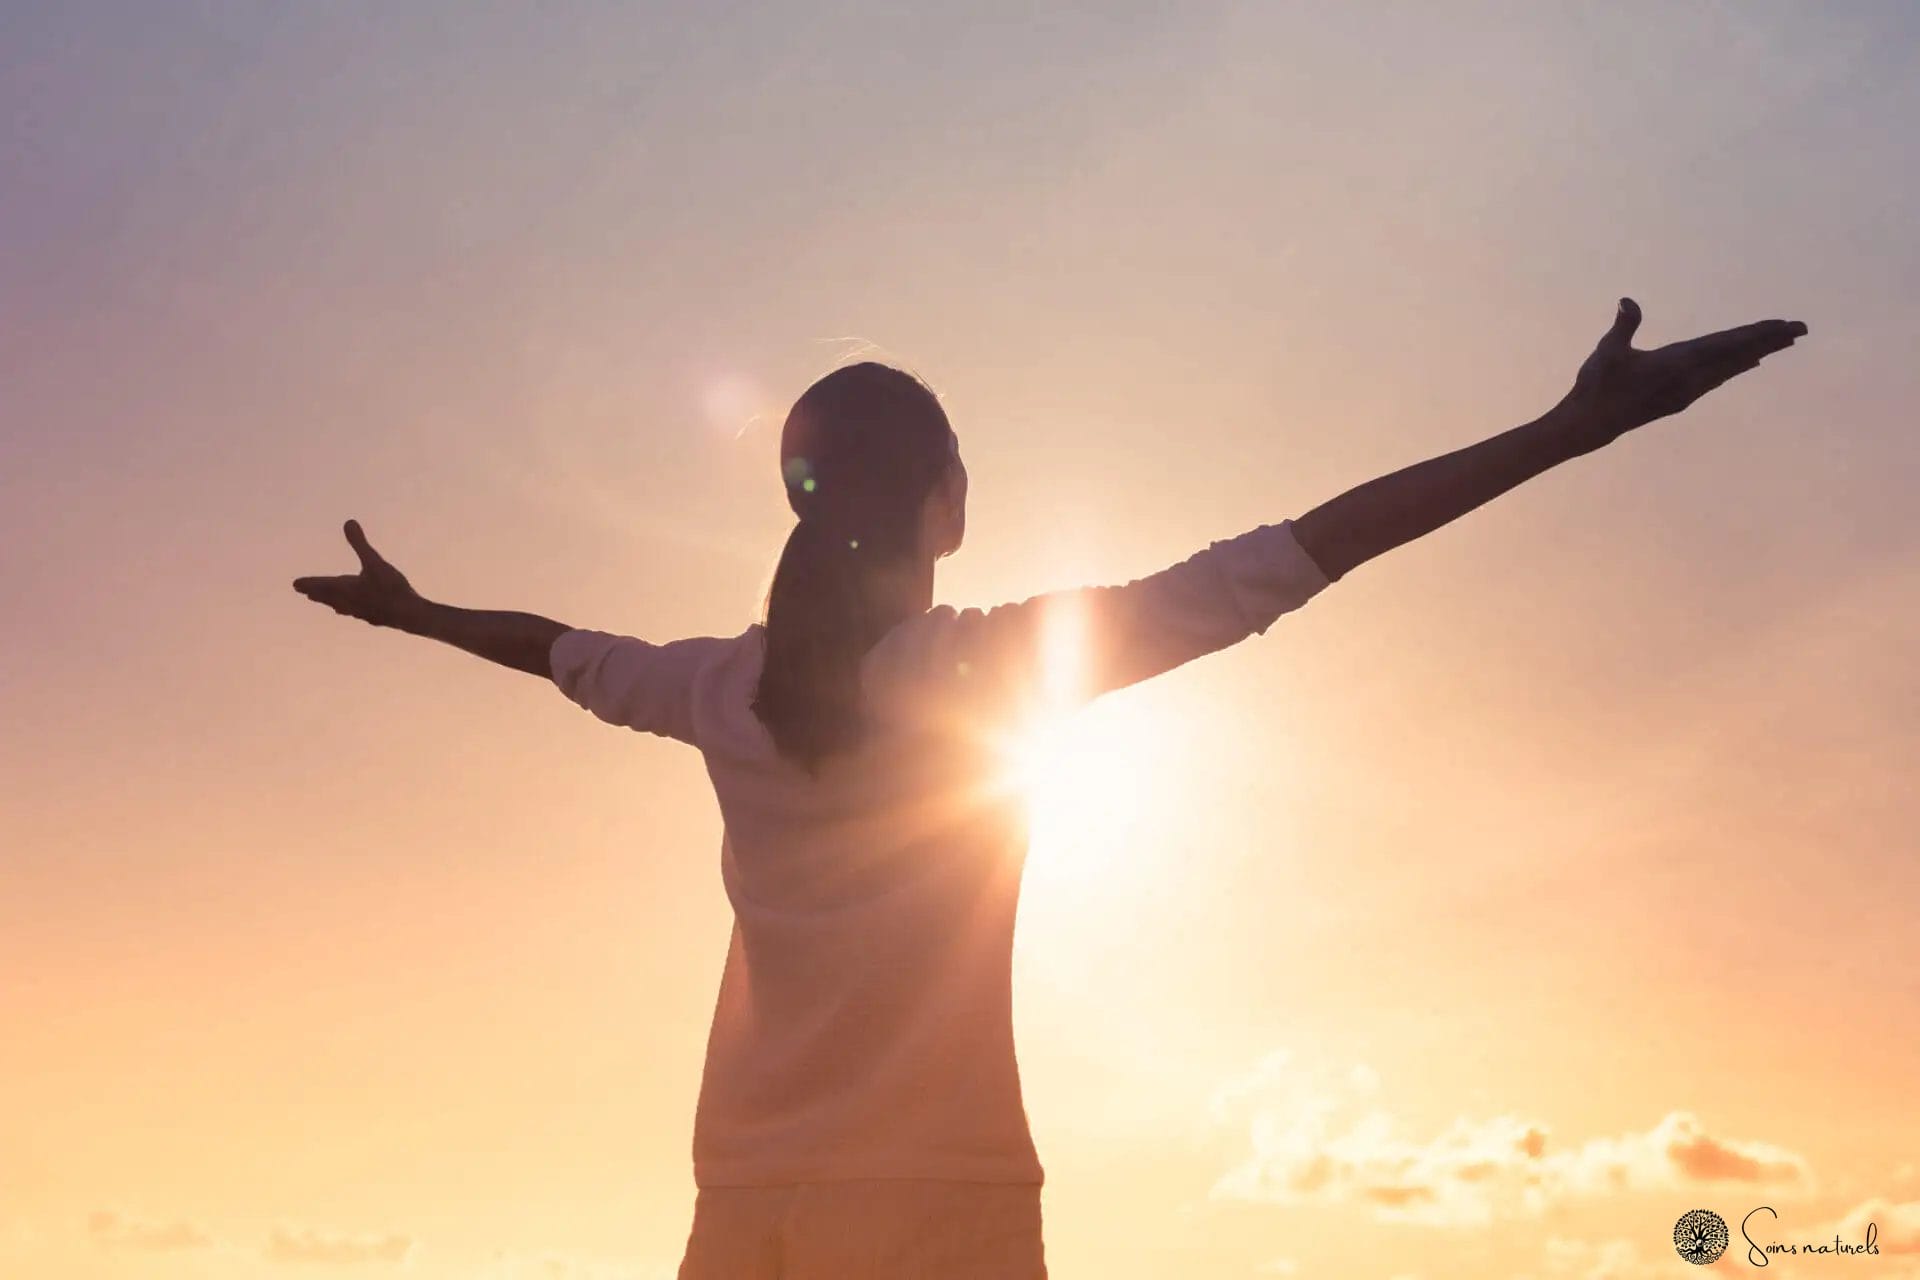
[294,520,570,679]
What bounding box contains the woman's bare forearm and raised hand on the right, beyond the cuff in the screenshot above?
[1294,297,1807,580]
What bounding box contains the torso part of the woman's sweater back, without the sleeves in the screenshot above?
[691,616,1041,1186]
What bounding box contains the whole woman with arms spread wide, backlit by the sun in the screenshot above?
[294,299,1807,1280]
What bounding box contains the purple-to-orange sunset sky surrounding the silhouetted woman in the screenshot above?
[0,0,1920,1280]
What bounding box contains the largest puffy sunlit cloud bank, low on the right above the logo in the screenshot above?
[1212,1054,1812,1226]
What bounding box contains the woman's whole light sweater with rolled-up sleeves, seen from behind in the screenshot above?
[549,520,1329,1186]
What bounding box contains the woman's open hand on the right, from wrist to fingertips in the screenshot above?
[1569,297,1807,438]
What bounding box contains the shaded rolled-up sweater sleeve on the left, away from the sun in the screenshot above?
[547,629,724,745]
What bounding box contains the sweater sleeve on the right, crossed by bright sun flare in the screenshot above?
[902,520,1329,721]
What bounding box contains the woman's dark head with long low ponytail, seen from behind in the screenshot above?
[753,361,952,771]
